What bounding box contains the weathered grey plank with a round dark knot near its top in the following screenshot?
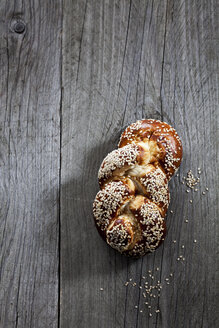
[0,0,62,328]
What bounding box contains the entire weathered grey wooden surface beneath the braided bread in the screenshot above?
[0,0,219,328]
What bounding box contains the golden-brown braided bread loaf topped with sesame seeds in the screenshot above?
[93,119,182,257]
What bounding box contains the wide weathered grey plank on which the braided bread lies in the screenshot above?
[60,0,218,328]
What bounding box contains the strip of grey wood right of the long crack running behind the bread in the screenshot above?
[158,1,219,327]
